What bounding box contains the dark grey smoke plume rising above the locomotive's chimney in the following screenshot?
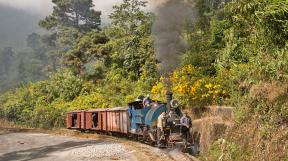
[150,0,194,74]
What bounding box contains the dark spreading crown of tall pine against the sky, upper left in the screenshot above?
[39,0,101,31]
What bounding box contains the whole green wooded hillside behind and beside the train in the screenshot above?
[0,0,288,161]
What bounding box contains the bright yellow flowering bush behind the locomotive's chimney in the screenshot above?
[151,65,225,107]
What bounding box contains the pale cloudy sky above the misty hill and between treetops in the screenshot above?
[0,0,122,18]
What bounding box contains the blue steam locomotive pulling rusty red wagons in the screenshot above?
[66,93,196,154]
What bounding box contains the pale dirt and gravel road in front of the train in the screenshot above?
[0,129,196,161]
